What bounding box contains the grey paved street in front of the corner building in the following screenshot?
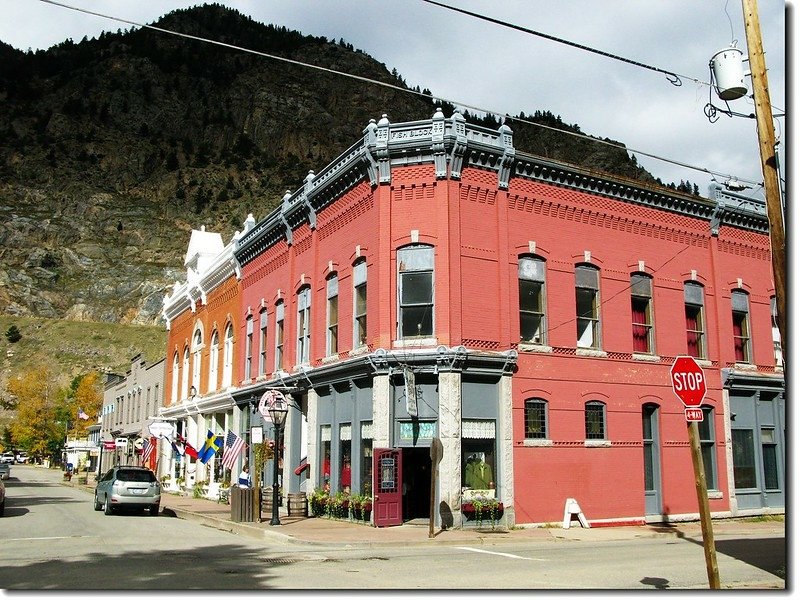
[0,466,786,590]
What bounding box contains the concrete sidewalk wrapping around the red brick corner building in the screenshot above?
[153,494,785,547]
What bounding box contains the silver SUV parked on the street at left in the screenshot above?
[94,465,161,515]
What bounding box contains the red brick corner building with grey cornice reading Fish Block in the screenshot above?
[161,111,786,526]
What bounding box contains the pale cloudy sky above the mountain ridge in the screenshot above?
[0,0,794,195]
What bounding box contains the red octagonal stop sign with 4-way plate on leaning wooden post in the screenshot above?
[669,356,720,589]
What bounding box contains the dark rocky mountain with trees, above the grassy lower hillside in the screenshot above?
[0,5,655,324]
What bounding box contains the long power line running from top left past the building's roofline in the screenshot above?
[39,0,761,186]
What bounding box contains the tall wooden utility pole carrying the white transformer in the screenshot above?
[742,0,789,364]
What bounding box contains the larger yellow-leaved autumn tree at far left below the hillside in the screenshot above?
[6,367,67,457]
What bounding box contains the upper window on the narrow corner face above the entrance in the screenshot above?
[397,244,434,338]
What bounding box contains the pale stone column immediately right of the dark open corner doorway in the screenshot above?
[435,371,461,528]
